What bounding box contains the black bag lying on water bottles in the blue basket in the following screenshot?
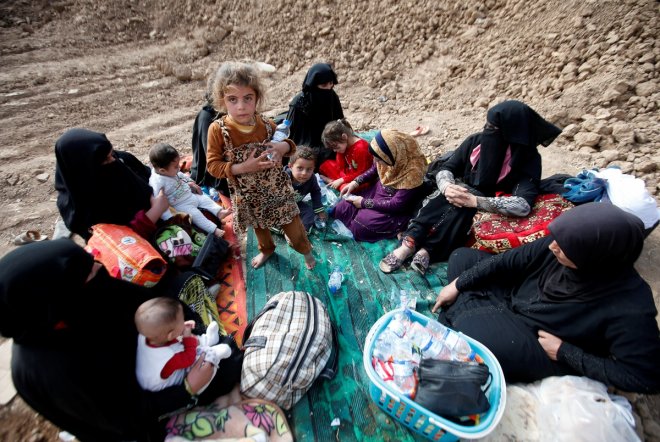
[415,359,493,416]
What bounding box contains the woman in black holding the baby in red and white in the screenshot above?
[0,239,241,442]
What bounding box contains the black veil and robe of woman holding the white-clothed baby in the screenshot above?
[55,129,152,239]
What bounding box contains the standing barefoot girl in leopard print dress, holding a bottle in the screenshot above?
[207,61,316,269]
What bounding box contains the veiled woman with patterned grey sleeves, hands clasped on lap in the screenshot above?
[380,100,561,274]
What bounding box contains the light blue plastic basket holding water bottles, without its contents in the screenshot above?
[362,310,506,442]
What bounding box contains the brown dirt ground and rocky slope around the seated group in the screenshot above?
[0,0,660,441]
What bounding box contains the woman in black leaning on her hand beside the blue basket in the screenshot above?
[433,203,660,394]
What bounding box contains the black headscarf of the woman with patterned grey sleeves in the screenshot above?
[474,100,561,194]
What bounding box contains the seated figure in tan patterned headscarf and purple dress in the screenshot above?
[333,129,426,242]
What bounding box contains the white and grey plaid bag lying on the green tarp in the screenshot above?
[241,292,338,409]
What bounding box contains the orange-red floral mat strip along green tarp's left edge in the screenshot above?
[216,195,247,346]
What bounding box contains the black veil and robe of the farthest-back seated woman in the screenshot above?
[287,63,344,164]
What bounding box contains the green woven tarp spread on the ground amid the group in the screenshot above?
[246,227,447,441]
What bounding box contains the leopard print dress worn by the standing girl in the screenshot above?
[216,116,300,233]
